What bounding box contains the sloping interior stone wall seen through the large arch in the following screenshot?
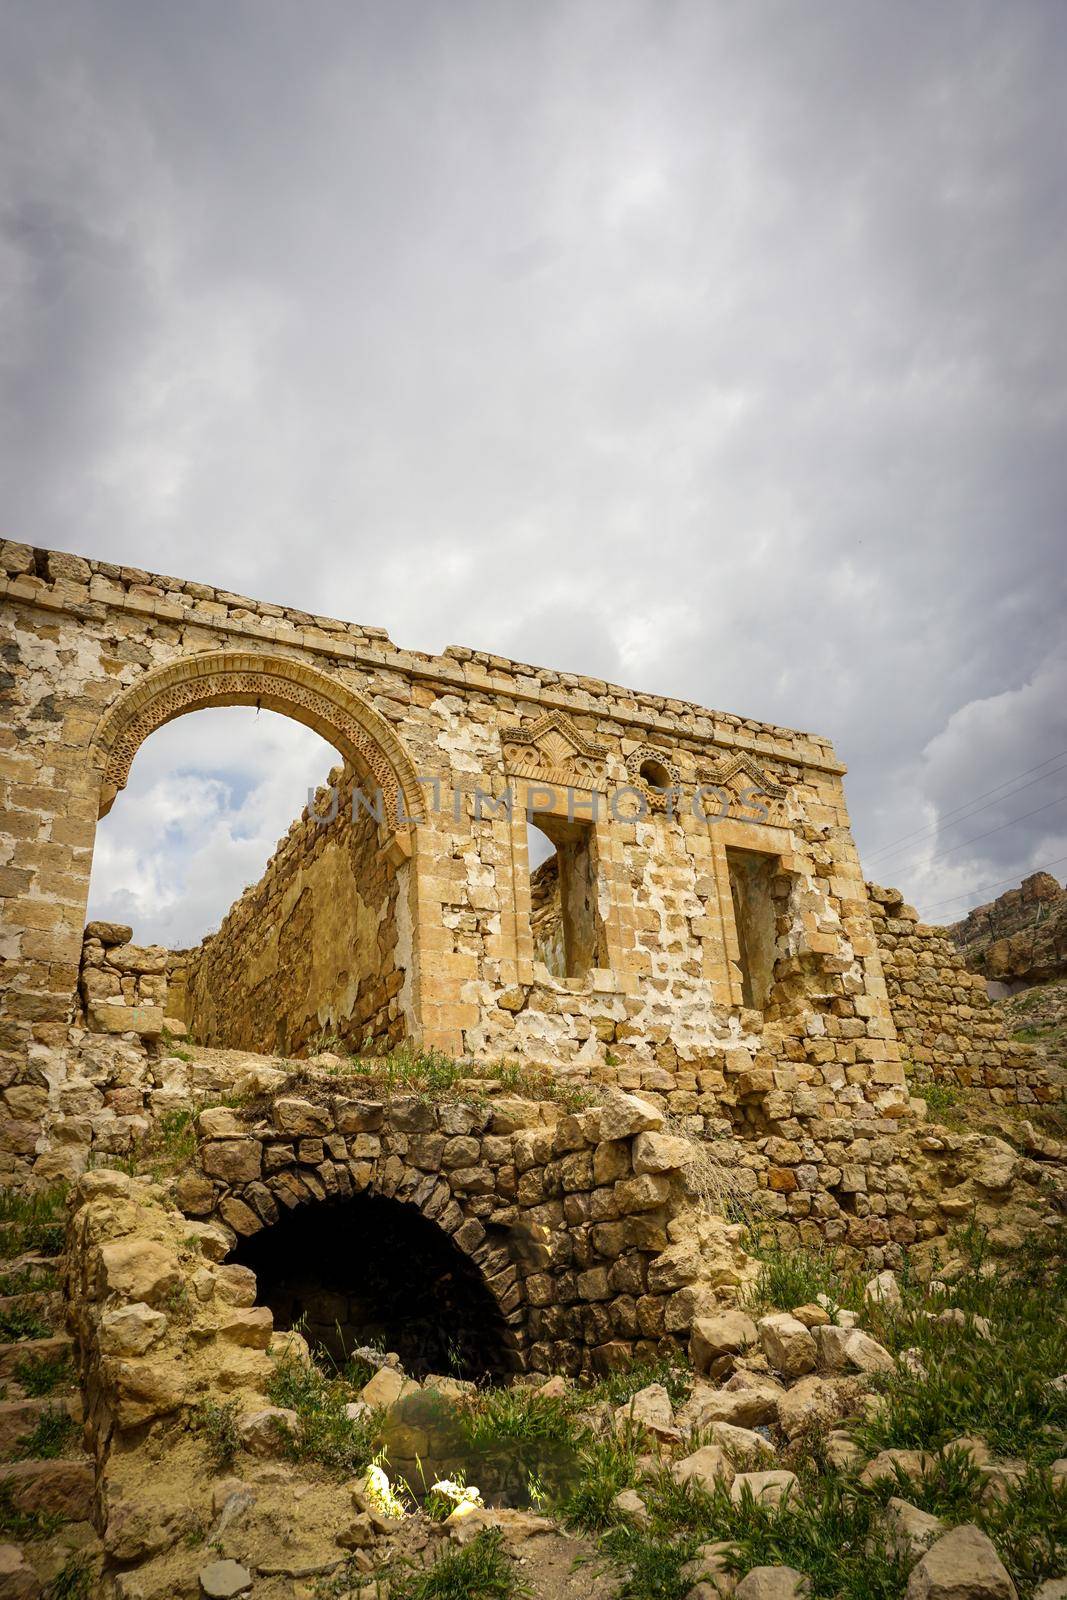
[186,770,410,1054]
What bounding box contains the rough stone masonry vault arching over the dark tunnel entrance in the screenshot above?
[176,1082,752,1373]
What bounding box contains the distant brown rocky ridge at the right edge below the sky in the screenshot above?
[947,872,1067,992]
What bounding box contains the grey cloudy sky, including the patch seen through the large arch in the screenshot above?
[0,0,1067,942]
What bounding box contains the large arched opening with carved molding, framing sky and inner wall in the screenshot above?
[78,654,421,1056]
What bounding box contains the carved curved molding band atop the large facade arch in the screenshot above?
[91,651,426,832]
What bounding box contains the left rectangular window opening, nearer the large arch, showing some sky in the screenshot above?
[526,813,608,979]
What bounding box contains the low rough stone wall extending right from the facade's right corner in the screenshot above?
[867,883,1067,1106]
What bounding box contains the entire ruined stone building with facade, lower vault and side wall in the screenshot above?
[0,542,1062,1365]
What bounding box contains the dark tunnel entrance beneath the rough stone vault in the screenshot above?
[229,1194,515,1379]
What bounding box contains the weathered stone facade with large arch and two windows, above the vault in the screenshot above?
[0,544,1061,1216]
